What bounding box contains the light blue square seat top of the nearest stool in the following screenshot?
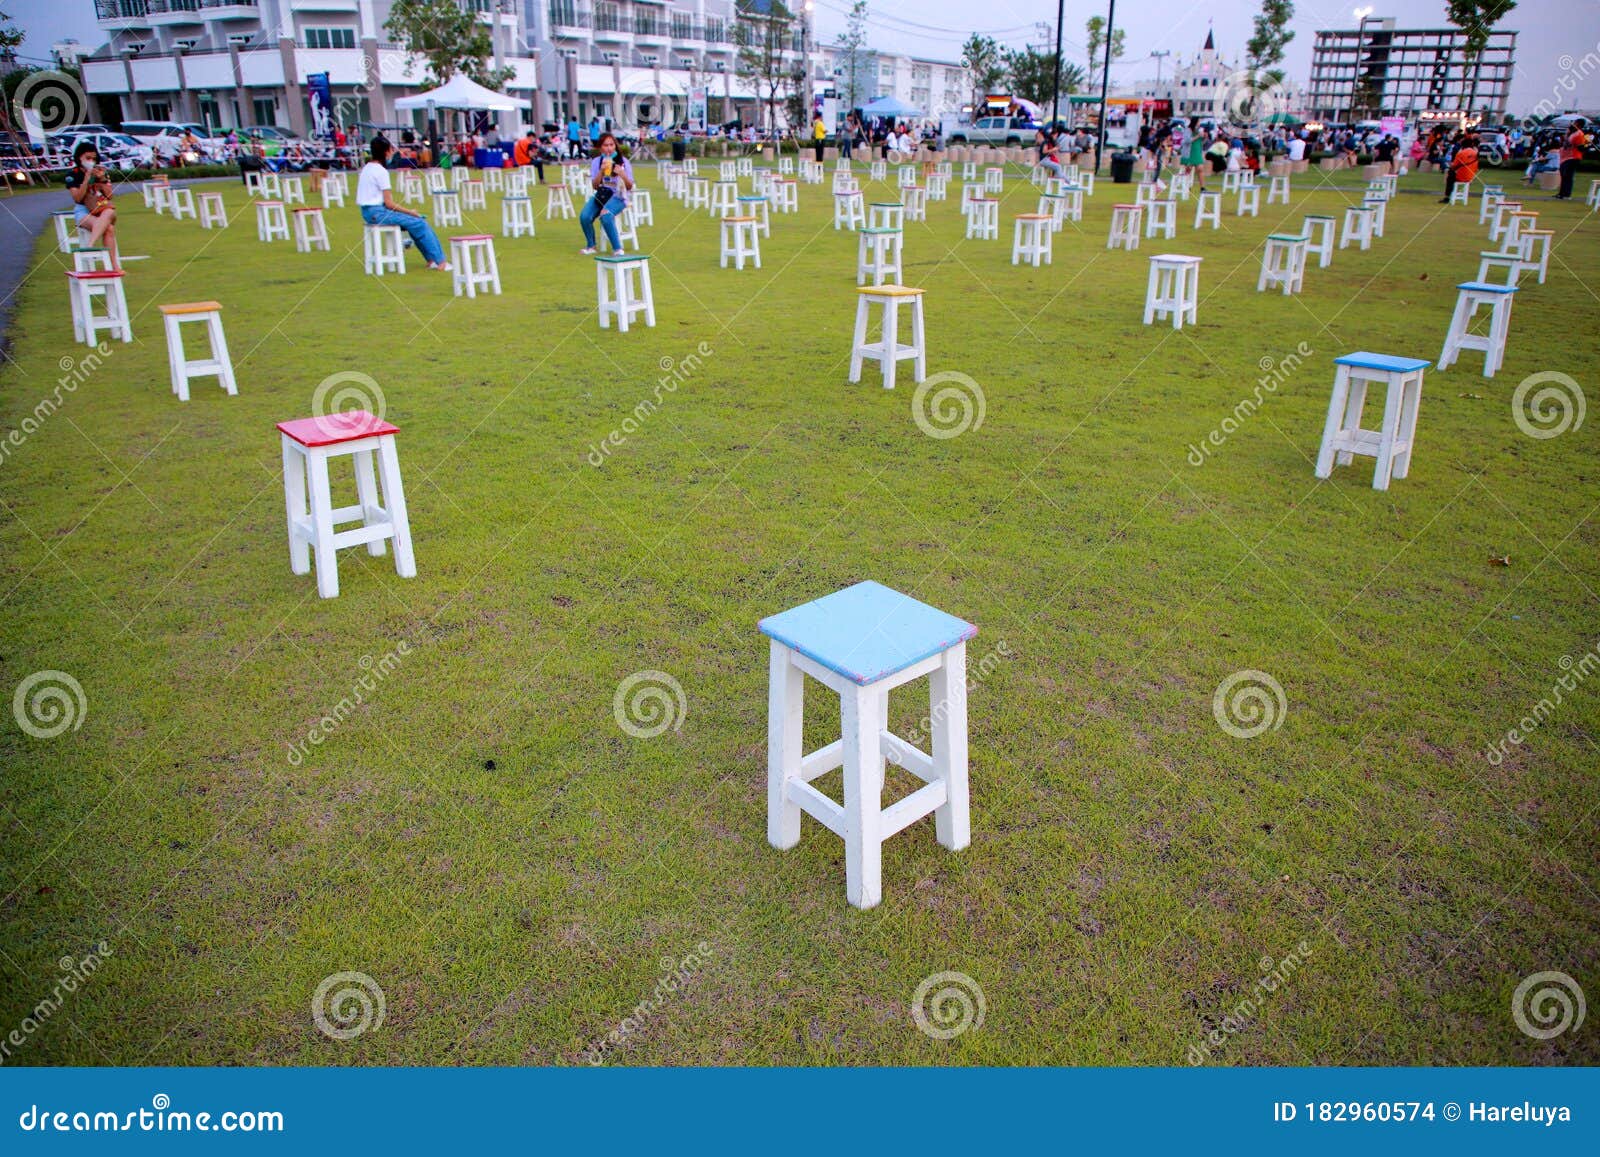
[757,579,978,687]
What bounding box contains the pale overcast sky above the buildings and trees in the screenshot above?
[12,0,1600,112]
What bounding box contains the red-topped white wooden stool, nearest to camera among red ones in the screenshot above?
[278,410,416,599]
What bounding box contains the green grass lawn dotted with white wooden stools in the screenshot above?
[0,164,1600,1064]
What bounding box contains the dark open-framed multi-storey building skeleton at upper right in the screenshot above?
[1307,19,1517,122]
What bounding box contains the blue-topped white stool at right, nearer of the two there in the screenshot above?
[1317,352,1429,490]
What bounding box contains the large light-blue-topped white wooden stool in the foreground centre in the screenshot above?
[760,583,978,907]
